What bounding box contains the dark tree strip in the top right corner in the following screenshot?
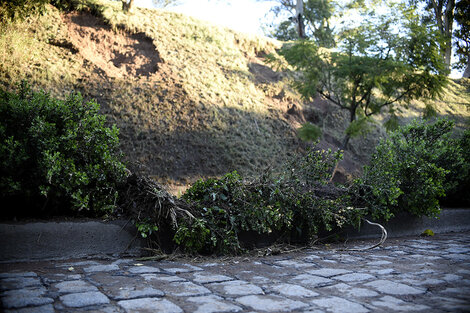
[454,0,470,78]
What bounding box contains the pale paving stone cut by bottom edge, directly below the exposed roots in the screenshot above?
[118,298,183,313]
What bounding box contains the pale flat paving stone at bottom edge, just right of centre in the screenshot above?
[236,295,308,312]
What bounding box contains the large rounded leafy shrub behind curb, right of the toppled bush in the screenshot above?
[357,119,463,220]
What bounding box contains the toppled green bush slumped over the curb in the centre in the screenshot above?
[178,150,359,252]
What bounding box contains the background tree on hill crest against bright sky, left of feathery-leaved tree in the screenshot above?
[269,0,335,47]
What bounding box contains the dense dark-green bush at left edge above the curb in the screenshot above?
[0,84,125,217]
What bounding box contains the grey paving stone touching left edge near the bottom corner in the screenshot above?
[0,287,54,309]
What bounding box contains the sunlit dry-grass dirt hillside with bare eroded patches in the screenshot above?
[0,0,470,191]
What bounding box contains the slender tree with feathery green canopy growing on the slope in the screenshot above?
[281,7,447,149]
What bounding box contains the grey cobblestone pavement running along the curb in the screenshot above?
[0,232,470,313]
